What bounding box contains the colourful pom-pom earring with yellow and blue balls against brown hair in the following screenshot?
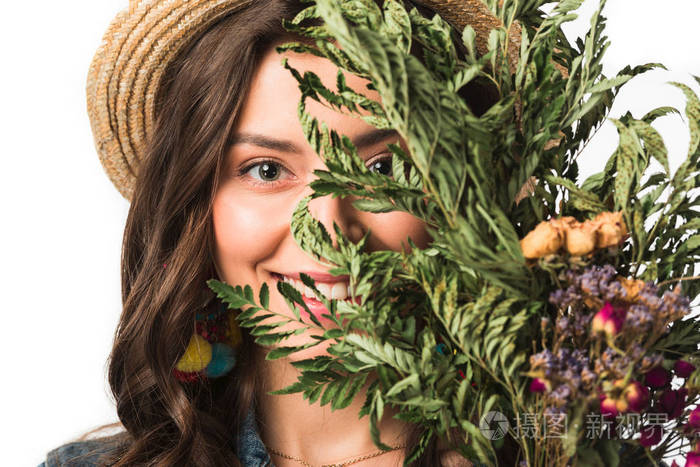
[173,298,242,383]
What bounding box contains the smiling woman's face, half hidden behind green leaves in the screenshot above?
[213,44,430,357]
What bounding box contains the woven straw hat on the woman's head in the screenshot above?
[87,0,520,200]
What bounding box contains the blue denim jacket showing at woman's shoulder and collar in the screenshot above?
[39,410,274,467]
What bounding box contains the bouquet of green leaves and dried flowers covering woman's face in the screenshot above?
[209,0,700,466]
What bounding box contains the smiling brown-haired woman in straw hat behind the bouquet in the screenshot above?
[46,0,516,466]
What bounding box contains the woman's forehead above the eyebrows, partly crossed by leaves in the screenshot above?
[236,48,379,139]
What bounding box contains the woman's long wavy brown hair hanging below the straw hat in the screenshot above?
[94,0,516,466]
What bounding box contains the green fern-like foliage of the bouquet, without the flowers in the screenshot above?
[209,0,700,465]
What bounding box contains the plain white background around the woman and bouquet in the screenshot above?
[0,0,700,466]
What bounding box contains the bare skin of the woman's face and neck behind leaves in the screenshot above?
[212,43,429,465]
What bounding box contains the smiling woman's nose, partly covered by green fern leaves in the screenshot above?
[309,191,367,248]
